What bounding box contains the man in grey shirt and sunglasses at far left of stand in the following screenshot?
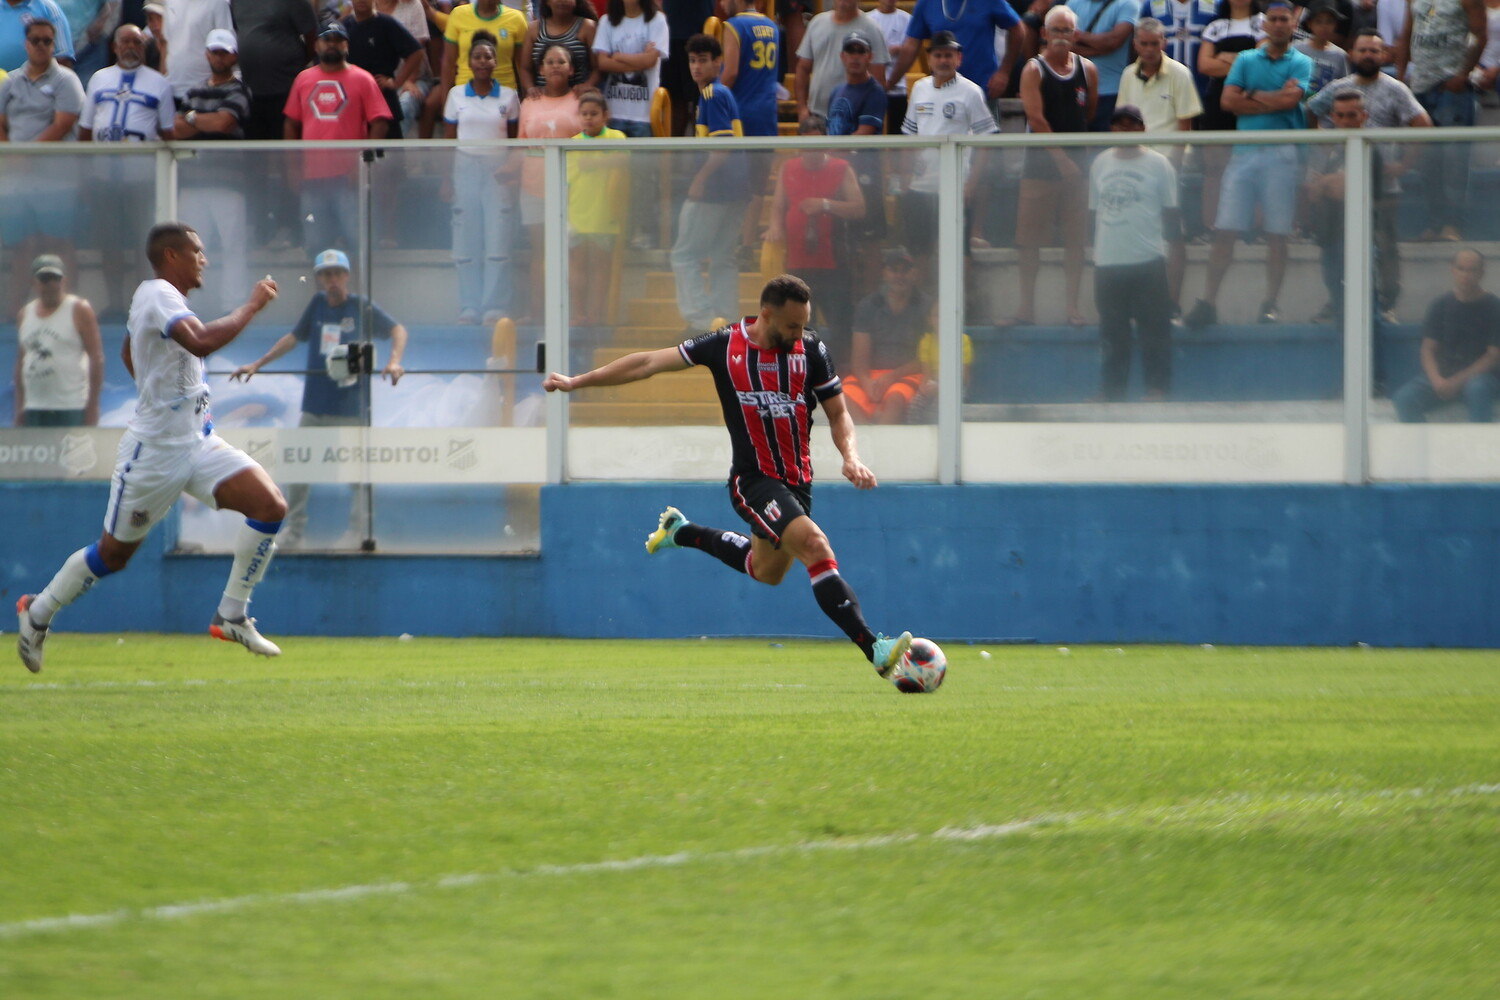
[0,21,84,313]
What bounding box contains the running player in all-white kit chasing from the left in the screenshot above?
[15,222,287,673]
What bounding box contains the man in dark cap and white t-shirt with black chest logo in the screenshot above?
[900,31,1001,258]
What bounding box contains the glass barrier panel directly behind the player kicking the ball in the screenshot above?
[567,142,936,481]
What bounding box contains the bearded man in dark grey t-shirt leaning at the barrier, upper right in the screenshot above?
[1308,28,1433,322]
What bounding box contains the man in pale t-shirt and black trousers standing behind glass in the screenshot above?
[1089,103,1178,402]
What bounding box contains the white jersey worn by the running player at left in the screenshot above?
[126,277,213,444]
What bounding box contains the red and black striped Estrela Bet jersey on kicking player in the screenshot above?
[677,316,843,486]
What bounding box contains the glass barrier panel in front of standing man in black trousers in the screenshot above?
[962,137,1343,481]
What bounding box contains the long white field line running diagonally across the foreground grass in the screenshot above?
[0,784,1500,940]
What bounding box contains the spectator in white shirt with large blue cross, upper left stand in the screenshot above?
[78,24,177,322]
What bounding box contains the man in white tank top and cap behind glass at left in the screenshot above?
[15,253,104,427]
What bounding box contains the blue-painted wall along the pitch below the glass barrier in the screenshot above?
[0,483,1500,648]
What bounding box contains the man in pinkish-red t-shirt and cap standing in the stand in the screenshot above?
[285,21,392,253]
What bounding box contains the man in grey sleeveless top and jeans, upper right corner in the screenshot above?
[1397,0,1490,243]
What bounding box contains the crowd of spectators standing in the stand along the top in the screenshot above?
[0,0,1500,419]
